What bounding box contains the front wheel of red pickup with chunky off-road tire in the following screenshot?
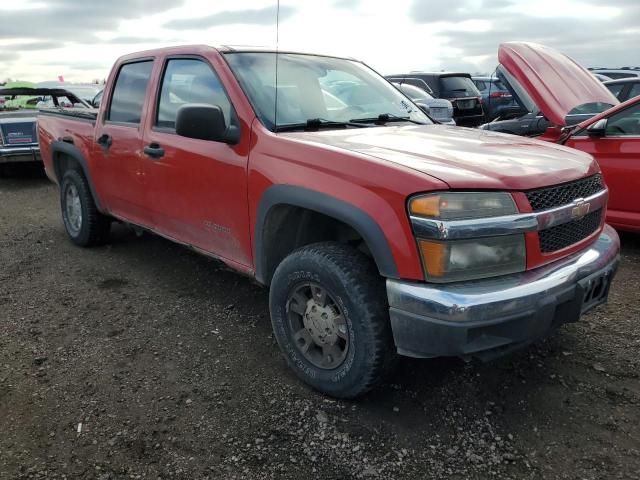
[269,243,396,398]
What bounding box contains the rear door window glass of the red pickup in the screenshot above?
[107,60,153,124]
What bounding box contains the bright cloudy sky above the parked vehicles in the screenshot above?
[0,0,640,82]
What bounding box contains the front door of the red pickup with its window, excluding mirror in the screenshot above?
[144,56,251,266]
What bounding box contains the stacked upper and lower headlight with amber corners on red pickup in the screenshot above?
[409,192,526,282]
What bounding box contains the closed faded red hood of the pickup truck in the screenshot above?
[281,125,598,190]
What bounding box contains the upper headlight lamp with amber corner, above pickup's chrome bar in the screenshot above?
[409,192,518,220]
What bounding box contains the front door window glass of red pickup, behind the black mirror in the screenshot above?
[156,58,231,129]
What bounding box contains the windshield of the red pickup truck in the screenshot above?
[226,52,432,130]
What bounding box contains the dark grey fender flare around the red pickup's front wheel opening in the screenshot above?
[254,185,399,285]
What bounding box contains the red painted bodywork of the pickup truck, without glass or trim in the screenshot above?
[39,46,598,280]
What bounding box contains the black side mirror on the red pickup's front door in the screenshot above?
[176,103,240,145]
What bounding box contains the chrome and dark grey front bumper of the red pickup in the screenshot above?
[387,226,620,359]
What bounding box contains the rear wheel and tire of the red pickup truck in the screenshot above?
[60,170,111,247]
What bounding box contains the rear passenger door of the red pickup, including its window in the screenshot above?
[92,59,154,227]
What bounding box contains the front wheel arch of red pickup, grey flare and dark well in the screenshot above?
[254,185,398,285]
